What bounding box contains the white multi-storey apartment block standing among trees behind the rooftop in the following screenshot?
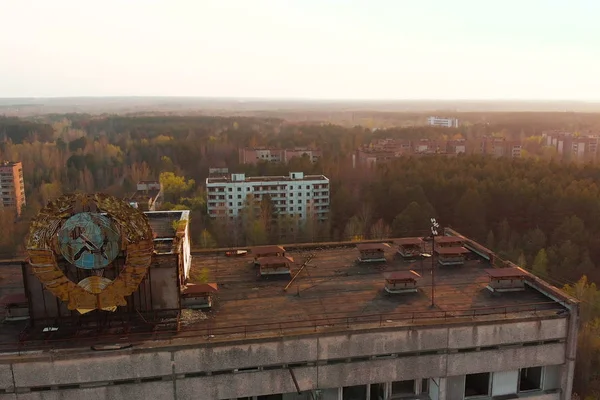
[206,172,329,221]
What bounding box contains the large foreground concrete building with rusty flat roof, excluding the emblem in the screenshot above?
[0,222,579,400]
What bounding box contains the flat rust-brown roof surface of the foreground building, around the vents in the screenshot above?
[0,239,567,350]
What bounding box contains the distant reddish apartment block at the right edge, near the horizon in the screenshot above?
[542,130,600,162]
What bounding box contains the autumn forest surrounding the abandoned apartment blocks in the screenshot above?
[0,113,600,394]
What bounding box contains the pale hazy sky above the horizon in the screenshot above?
[0,0,600,100]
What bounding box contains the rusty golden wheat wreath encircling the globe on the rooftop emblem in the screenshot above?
[27,193,154,314]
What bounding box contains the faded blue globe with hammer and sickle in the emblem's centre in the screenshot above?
[58,212,121,269]
